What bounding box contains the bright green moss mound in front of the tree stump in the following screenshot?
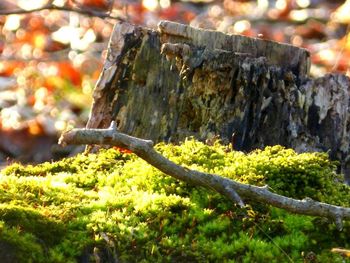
[0,140,350,262]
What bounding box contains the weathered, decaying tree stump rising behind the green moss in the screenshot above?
[87,21,350,182]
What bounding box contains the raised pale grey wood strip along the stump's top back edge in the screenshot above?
[158,21,310,76]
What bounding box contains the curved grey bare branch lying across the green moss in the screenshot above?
[59,122,350,230]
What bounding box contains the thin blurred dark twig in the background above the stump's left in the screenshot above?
[0,3,124,21]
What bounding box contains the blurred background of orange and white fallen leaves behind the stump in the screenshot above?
[0,0,350,166]
